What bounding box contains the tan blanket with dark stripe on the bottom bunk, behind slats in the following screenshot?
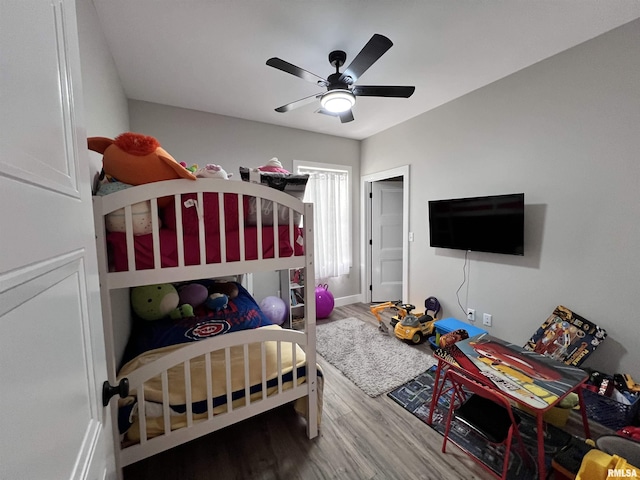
[119,325,323,445]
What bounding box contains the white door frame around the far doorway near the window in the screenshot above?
[360,165,409,303]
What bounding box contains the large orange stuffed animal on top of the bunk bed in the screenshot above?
[88,132,196,185]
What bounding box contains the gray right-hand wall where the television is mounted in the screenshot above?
[361,20,640,373]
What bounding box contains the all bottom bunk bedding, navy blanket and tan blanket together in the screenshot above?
[118,280,323,444]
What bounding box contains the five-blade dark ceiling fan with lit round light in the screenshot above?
[267,33,416,123]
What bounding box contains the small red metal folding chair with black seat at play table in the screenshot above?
[441,369,528,479]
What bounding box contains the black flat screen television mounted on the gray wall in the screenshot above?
[429,193,524,255]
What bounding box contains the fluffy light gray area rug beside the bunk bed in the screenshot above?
[316,318,437,397]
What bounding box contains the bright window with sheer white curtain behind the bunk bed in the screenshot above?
[293,161,352,279]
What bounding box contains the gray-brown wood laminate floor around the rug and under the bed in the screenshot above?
[124,304,605,480]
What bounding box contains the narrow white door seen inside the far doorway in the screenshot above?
[371,180,403,302]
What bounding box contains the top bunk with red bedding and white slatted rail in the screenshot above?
[94,179,308,278]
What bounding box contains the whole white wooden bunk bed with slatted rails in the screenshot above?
[94,179,322,469]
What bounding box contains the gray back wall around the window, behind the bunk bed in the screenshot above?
[129,100,360,300]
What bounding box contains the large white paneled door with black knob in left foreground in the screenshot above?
[0,0,115,480]
